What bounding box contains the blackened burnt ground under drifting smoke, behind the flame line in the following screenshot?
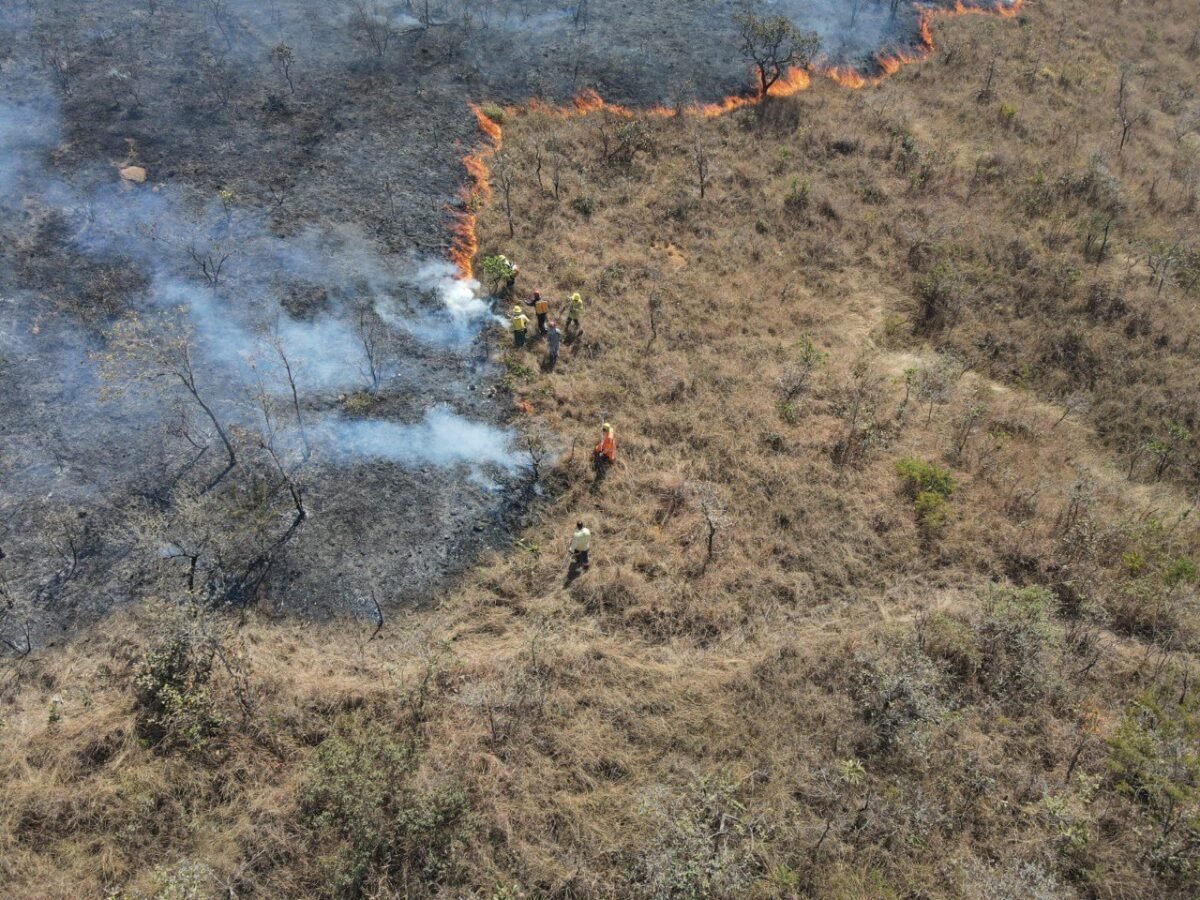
[0,0,1003,649]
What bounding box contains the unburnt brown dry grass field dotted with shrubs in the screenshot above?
[0,0,1200,899]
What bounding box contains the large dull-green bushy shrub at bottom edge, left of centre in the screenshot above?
[300,722,472,896]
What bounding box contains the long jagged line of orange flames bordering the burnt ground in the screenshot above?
[450,0,1025,278]
